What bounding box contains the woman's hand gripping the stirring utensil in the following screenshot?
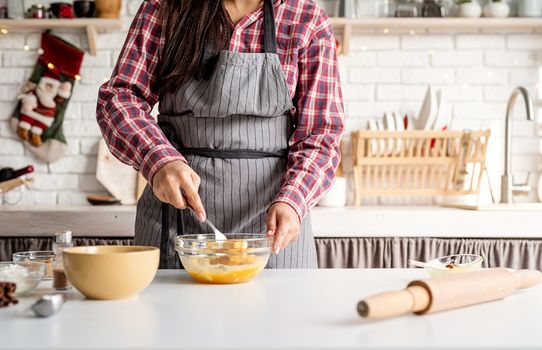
[152,160,205,222]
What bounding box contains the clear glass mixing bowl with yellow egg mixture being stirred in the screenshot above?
[175,234,273,284]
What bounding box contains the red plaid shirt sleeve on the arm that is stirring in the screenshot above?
[96,1,185,184]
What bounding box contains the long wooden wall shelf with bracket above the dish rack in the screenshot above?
[330,17,542,54]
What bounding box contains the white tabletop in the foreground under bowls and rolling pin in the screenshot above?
[0,269,542,349]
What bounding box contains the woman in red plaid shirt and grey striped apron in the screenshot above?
[97,0,343,268]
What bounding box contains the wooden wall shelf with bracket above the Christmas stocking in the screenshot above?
[0,18,122,56]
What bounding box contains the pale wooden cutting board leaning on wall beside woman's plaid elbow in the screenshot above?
[96,140,147,205]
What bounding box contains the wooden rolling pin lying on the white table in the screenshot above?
[358,268,542,319]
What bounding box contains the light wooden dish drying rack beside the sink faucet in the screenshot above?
[351,130,491,206]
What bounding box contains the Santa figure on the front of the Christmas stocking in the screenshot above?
[17,73,72,147]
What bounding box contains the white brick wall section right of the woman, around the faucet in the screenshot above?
[340,31,542,202]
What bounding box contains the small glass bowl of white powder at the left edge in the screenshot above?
[0,261,47,296]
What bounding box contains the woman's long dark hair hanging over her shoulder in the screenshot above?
[159,0,231,91]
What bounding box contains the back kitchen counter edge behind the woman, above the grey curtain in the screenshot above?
[0,206,542,238]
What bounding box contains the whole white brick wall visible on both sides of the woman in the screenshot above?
[0,0,542,204]
